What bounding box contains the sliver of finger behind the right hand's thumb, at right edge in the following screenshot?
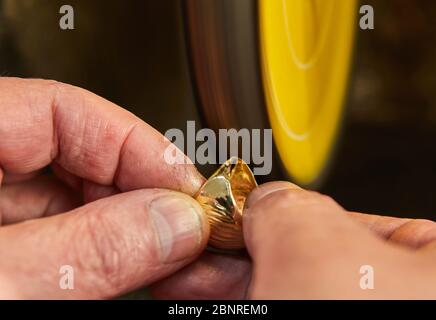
[349,212,436,249]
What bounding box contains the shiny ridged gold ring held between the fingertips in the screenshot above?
[195,158,257,250]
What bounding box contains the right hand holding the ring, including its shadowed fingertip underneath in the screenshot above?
[152,182,436,299]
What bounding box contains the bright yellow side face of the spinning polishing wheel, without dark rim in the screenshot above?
[258,0,357,185]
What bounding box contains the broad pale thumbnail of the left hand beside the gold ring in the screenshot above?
[149,195,203,263]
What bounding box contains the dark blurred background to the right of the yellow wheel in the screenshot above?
[322,0,436,219]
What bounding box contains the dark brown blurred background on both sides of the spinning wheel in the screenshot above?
[0,0,436,219]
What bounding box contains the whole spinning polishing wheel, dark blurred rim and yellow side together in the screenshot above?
[185,0,357,186]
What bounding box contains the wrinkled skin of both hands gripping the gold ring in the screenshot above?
[0,78,436,299]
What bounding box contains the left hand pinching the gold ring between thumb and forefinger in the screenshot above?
[0,78,209,299]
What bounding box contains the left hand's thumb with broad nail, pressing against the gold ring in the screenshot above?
[0,189,209,299]
